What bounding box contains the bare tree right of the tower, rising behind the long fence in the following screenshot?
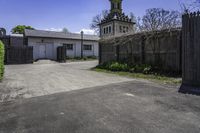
[137,8,181,31]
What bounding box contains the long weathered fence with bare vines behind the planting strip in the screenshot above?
[100,29,182,72]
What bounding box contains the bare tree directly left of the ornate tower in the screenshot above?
[90,10,109,33]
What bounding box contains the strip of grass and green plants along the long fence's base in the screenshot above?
[92,62,182,84]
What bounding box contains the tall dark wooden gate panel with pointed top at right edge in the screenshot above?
[180,12,200,95]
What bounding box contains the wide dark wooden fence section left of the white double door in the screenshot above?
[5,46,33,64]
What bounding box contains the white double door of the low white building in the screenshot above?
[34,43,54,59]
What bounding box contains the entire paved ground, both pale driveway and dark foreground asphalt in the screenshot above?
[0,61,200,133]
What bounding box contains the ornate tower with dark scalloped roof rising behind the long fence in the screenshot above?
[99,0,135,38]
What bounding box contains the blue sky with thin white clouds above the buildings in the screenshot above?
[0,0,184,32]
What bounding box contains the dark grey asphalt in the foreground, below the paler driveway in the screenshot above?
[0,81,200,133]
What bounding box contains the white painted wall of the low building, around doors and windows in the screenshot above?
[28,38,99,60]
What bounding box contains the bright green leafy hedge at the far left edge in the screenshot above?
[0,41,5,81]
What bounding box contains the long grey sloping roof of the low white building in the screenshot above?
[24,29,99,41]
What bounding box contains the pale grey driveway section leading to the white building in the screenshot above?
[0,61,133,102]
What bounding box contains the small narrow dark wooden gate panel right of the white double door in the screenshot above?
[57,46,66,62]
